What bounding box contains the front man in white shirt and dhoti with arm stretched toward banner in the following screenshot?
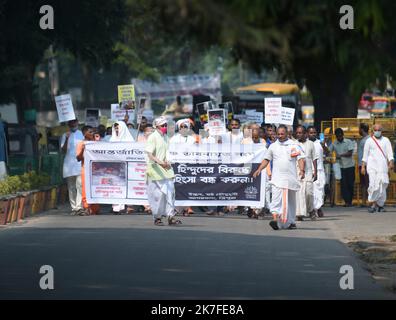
[253,125,305,230]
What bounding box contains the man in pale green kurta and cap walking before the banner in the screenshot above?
[145,117,181,226]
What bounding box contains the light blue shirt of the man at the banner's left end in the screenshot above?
[61,130,84,178]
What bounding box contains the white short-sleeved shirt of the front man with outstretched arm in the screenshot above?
[264,139,305,191]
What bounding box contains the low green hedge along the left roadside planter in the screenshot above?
[0,171,51,196]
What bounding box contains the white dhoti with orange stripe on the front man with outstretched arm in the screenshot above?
[270,185,297,229]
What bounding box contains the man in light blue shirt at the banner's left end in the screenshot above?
[61,120,84,215]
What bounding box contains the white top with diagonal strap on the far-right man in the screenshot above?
[362,137,394,176]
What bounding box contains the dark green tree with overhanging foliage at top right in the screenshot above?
[141,0,396,127]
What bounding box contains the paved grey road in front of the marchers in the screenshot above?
[0,209,395,299]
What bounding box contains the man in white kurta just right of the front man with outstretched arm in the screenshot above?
[296,126,318,221]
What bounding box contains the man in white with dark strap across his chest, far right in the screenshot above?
[361,124,394,213]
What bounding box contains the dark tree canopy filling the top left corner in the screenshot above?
[0,0,126,120]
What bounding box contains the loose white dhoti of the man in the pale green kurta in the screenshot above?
[147,179,175,220]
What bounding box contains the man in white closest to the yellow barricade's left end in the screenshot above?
[308,127,326,218]
